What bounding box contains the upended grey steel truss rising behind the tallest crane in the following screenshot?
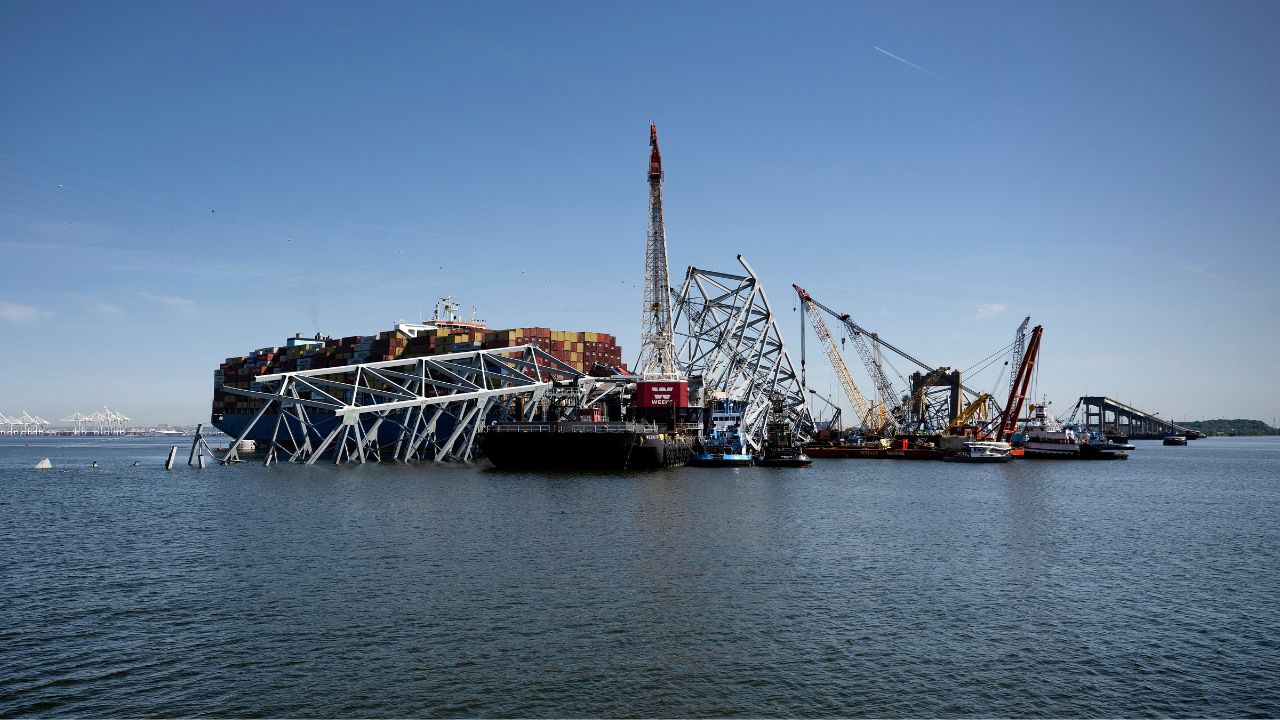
[675,255,814,451]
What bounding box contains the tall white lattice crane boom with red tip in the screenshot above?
[636,123,680,380]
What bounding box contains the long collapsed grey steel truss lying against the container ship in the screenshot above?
[221,346,584,465]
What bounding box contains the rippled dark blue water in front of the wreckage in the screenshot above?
[0,430,1280,716]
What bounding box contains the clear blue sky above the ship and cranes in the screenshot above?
[0,0,1280,423]
